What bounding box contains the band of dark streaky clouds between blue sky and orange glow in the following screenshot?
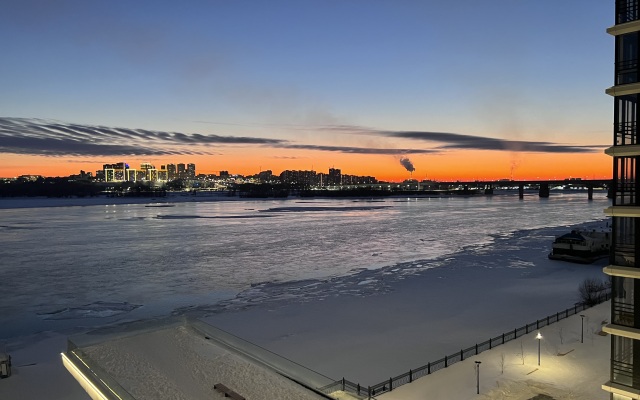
[0,117,607,156]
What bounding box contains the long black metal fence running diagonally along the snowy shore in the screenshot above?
[318,292,611,399]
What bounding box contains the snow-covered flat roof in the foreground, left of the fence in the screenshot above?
[83,326,322,400]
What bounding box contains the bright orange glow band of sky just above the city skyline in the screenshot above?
[0,150,613,182]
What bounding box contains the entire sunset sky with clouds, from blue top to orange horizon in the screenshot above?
[0,0,614,181]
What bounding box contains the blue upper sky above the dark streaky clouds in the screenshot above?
[0,0,614,178]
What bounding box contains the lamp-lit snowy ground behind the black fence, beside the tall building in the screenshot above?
[378,302,611,400]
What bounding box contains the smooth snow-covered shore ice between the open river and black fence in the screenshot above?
[202,219,605,385]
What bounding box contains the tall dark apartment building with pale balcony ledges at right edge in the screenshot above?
[602,0,640,400]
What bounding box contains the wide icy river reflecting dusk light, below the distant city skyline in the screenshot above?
[0,193,609,339]
